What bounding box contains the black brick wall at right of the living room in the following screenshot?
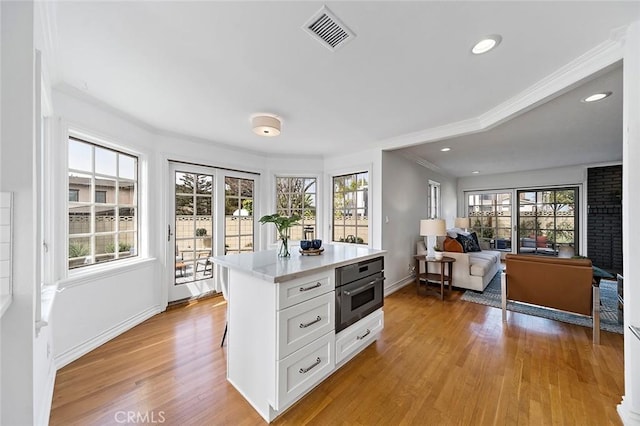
[587,165,622,273]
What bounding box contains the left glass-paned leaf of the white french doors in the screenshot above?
[169,163,216,301]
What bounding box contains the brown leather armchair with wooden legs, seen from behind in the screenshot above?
[502,254,600,344]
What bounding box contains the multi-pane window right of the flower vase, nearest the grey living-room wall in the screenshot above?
[332,172,369,244]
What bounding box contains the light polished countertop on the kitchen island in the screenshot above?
[211,244,387,283]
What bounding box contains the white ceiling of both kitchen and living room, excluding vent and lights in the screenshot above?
[51,1,640,176]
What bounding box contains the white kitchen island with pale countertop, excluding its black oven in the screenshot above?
[211,244,386,422]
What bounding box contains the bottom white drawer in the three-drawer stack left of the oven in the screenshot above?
[275,333,335,410]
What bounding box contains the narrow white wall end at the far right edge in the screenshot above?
[618,21,640,425]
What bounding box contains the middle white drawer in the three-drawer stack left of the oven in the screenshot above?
[276,291,336,359]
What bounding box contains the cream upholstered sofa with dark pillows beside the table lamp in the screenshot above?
[417,241,501,291]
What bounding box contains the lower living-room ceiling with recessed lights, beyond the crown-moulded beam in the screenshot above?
[397,63,622,177]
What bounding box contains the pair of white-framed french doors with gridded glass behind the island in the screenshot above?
[167,162,256,301]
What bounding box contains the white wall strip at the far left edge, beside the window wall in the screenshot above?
[0,2,37,425]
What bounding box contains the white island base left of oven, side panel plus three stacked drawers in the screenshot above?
[227,269,335,421]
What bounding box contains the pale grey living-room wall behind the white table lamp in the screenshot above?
[381,152,456,293]
